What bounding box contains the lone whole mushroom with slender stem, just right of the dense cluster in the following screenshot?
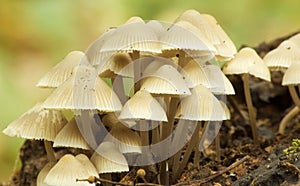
[223,47,270,145]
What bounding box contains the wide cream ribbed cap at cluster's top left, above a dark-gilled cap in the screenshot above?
[101,17,161,53]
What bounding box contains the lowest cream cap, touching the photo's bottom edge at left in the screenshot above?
[44,154,93,186]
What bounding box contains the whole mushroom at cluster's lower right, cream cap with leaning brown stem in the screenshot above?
[172,85,228,180]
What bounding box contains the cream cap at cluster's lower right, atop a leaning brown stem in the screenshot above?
[175,85,227,121]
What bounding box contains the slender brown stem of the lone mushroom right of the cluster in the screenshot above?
[242,73,258,145]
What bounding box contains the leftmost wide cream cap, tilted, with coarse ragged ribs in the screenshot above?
[3,103,68,141]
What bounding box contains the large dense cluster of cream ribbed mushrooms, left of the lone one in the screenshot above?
[3,10,237,185]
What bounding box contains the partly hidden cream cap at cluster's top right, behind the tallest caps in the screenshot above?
[202,14,237,61]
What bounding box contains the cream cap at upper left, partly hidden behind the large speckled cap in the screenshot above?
[36,51,84,88]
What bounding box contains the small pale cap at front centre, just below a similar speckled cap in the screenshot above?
[119,90,168,121]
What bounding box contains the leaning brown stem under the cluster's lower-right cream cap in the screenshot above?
[172,121,203,182]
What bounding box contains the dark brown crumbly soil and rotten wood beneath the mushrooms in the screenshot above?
[0,33,300,186]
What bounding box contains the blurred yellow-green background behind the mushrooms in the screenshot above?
[0,0,300,181]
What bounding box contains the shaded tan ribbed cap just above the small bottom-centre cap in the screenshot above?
[104,123,142,153]
